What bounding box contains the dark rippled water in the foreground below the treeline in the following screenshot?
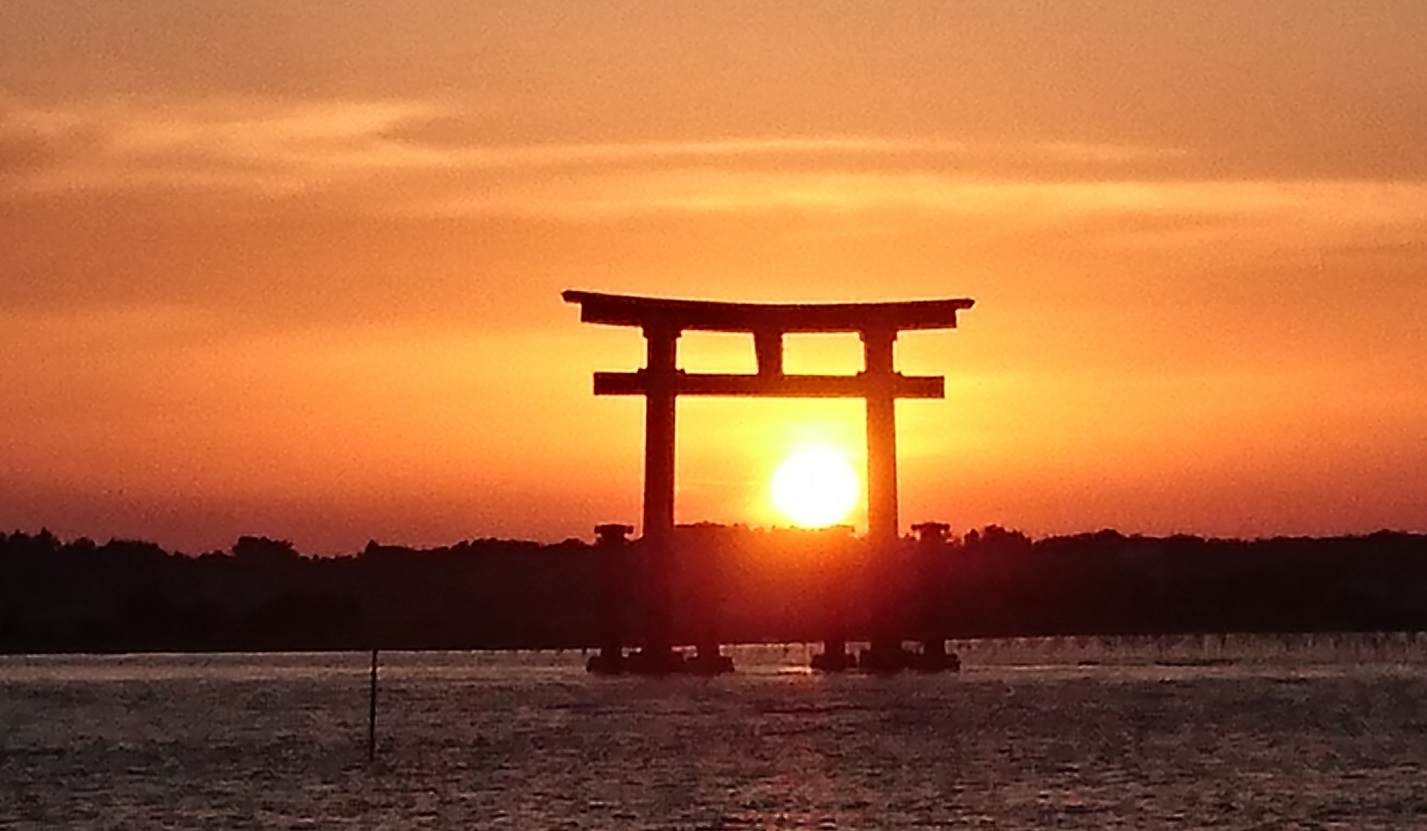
[0,635,1427,830]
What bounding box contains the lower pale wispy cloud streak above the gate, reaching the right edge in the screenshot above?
[428,167,1427,251]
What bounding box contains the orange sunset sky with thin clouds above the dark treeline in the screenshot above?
[0,0,1427,553]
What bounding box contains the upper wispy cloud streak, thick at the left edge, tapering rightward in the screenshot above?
[0,99,1184,191]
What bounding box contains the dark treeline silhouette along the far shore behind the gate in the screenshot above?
[0,524,1427,653]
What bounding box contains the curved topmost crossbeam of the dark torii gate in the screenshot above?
[561,291,973,334]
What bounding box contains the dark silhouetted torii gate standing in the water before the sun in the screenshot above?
[561,291,973,671]
